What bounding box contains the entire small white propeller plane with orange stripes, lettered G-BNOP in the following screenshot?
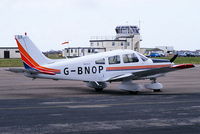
[9,35,194,93]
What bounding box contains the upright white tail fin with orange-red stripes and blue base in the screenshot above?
[15,35,60,74]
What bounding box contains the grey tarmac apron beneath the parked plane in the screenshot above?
[0,66,200,134]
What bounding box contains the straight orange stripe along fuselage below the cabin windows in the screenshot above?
[106,64,171,71]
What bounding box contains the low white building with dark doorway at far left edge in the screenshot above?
[0,47,20,58]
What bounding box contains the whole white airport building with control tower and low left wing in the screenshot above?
[63,26,141,57]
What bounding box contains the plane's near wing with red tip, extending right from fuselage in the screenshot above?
[108,64,195,82]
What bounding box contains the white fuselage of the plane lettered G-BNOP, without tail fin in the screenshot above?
[31,50,172,82]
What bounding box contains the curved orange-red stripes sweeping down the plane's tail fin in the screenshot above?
[16,39,60,74]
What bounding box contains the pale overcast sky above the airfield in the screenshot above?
[0,0,200,51]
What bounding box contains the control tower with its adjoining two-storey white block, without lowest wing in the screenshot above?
[90,25,141,52]
